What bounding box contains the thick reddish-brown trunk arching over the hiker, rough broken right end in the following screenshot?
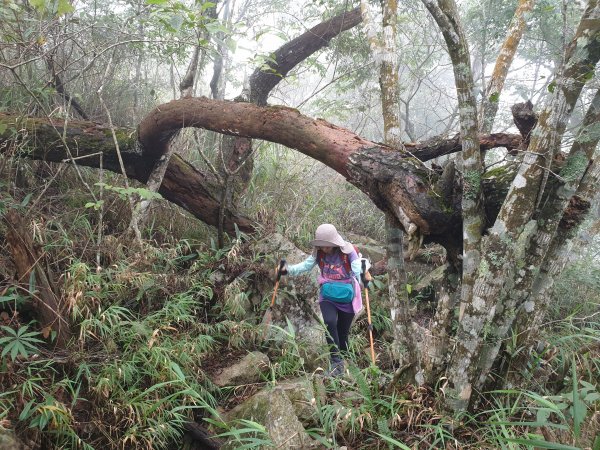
[139,98,460,243]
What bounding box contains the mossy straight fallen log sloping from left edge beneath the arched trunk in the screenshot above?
[0,113,255,233]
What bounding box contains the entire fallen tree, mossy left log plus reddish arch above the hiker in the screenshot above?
[0,107,521,251]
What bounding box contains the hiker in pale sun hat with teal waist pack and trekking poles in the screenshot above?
[278,223,362,377]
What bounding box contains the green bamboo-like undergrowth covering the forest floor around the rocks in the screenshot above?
[0,166,600,450]
